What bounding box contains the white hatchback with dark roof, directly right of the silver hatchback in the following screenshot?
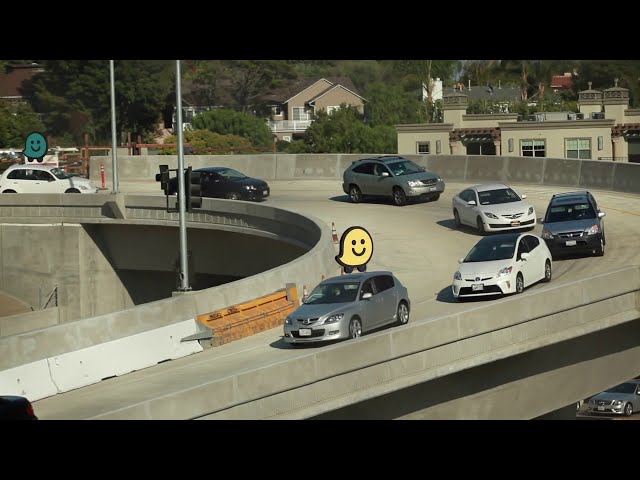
[451,232,553,300]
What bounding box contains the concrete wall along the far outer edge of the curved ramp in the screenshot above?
[90,153,640,193]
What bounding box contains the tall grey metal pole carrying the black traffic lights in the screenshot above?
[176,60,191,292]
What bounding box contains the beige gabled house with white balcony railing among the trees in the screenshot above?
[261,77,366,141]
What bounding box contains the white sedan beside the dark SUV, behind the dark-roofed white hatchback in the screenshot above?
[452,183,536,234]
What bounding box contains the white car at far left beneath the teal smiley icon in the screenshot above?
[0,164,98,193]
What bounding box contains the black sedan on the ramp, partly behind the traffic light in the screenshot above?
[169,167,271,201]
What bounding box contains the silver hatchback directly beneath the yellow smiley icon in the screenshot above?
[284,271,411,345]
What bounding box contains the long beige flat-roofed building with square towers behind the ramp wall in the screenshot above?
[396,80,640,162]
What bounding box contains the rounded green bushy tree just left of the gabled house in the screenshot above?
[191,108,273,147]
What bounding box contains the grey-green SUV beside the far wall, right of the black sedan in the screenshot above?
[342,155,445,206]
